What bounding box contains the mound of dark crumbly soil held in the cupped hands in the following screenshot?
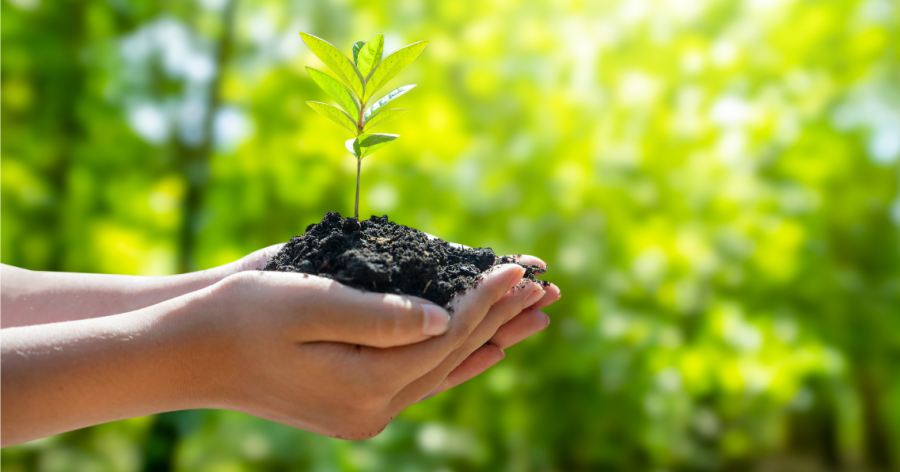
[264,212,548,306]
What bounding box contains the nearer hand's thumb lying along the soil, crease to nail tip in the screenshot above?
[310,289,450,348]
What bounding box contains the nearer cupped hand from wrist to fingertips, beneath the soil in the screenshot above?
[191,264,546,439]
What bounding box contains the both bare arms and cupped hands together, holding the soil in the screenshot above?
[0,246,559,447]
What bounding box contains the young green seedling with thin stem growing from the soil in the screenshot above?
[300,33,428,219]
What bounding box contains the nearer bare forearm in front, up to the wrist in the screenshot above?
[0,294,216,446]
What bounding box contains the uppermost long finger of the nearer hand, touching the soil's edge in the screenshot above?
[374,264,525,381]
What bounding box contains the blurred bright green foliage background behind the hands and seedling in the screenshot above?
[0,0,900,472]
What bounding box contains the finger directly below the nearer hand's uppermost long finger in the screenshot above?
[386,281,542,405]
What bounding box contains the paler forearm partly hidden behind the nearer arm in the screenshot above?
[0,265,234,328]
